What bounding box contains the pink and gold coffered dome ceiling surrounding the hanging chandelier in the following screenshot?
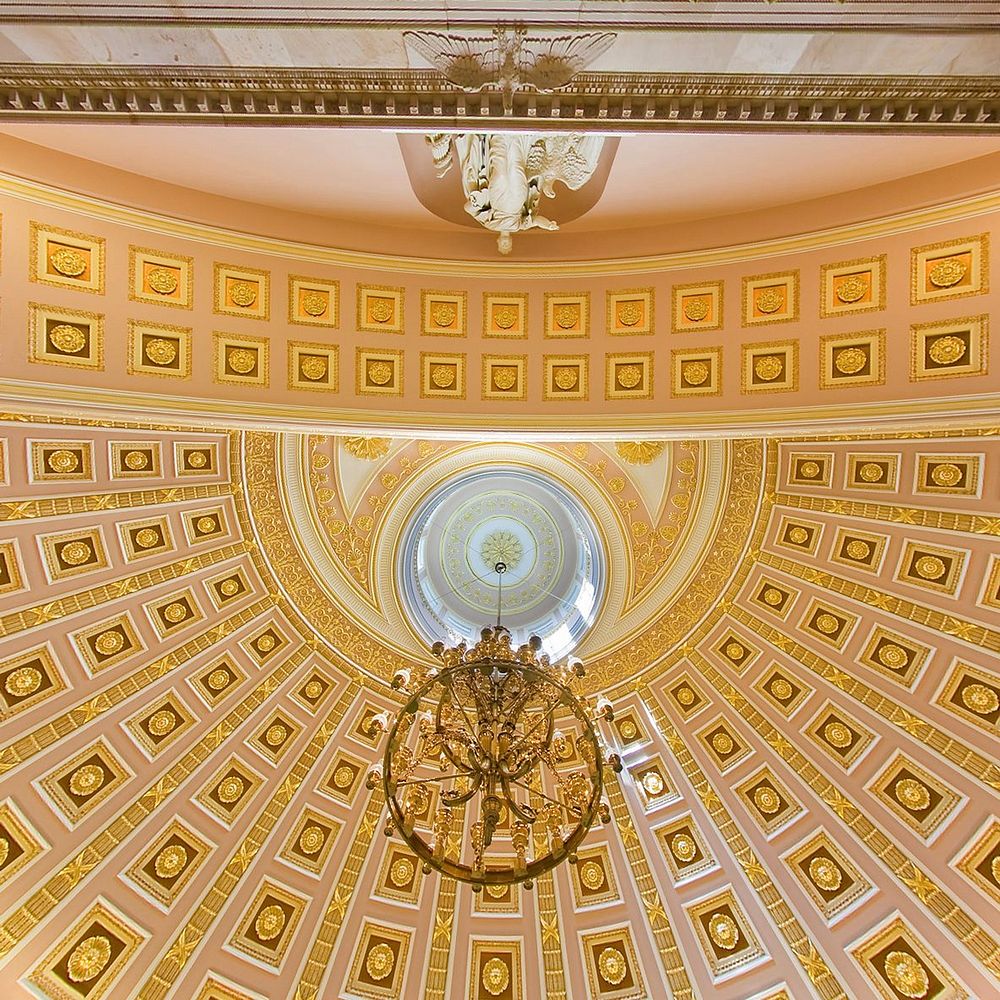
[0,414,1000,1000]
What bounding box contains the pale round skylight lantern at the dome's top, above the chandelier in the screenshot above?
[398,468,605,660]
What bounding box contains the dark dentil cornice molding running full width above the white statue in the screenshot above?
[0,63,1000,134]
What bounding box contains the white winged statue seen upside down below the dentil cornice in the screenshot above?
[427,132,604,254]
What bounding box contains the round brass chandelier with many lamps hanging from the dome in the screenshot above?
[368,562,622,892]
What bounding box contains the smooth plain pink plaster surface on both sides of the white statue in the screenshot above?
[0,124,1000,232]
